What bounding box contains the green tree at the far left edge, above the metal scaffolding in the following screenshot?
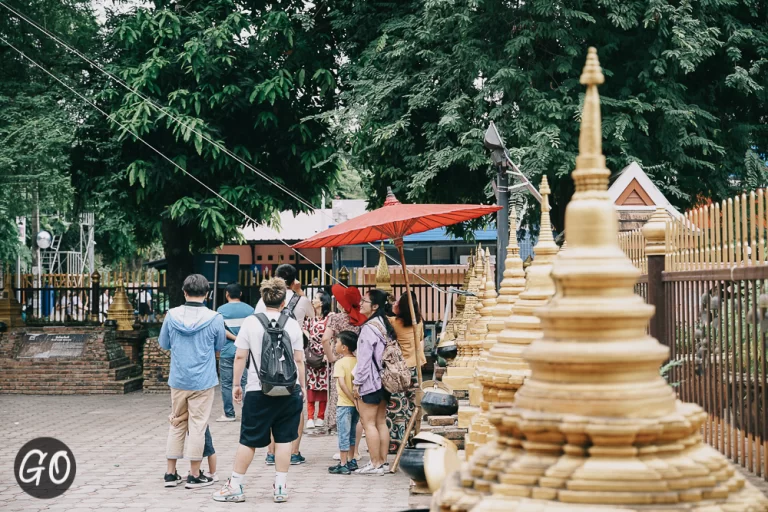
[0,0,98,261]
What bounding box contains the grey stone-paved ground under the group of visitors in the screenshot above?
[0,390,409,512]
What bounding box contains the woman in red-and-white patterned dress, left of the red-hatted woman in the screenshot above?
[304,290,331,428]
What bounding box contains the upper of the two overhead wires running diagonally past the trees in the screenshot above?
[0,0,447,293]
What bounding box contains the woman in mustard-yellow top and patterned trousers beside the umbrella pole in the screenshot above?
[387,292,427,453]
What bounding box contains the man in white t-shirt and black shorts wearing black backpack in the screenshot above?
[213,278,306,503]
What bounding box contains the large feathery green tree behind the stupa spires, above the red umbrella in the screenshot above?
[334,0,768,228]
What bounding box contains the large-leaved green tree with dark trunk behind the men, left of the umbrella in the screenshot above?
[77,0,338,305]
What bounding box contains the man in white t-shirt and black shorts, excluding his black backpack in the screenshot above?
[213,278,306,503]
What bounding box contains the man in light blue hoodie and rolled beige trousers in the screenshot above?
[158,274,227,489]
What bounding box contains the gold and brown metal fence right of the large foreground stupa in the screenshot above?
[622,190,768,480]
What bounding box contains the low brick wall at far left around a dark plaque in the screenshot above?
[0,327,141,395]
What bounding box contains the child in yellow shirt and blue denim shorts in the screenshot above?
[328,331,360,475]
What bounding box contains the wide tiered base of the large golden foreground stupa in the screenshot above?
[433,401,768,512]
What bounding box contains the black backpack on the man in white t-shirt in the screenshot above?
[249,312,298,396]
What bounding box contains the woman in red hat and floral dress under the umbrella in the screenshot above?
[323,284,366,433]
